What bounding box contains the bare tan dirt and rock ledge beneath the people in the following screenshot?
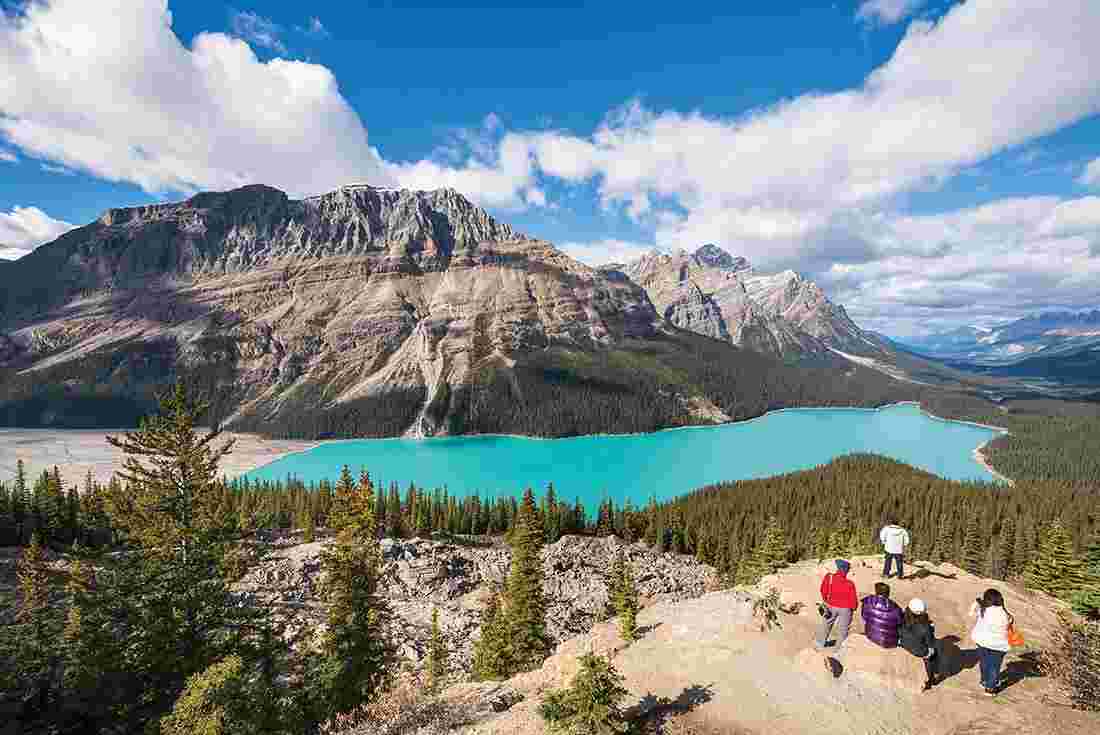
[468,557,1100,735]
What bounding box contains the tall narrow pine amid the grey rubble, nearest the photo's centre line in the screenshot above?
[503,489,550,671]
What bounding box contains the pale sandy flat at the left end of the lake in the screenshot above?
[0,428,318,486]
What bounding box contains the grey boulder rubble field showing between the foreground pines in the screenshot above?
[239,536,717,671]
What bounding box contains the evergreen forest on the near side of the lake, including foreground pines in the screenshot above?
[0,383,1100,733]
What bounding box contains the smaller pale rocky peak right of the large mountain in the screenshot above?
[619,244,884,358]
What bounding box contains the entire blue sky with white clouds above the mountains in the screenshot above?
[0,0,1100,334]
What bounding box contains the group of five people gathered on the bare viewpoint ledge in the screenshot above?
[815,519,1012,696]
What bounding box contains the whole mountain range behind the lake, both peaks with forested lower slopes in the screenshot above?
[0,185,914,437]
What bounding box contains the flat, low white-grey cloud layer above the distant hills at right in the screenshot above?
[817,197,1100,333]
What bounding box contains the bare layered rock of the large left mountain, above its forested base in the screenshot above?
[0,186,659,436]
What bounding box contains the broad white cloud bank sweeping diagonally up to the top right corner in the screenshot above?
[512,0,1100,271]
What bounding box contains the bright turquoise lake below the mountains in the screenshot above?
[248,404,1000,508]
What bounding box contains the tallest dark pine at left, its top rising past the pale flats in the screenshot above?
[97,383,249,717]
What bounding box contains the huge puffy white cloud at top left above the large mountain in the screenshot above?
[0,0,392,195]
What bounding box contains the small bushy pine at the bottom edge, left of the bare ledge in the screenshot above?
[539,652,628,735]
